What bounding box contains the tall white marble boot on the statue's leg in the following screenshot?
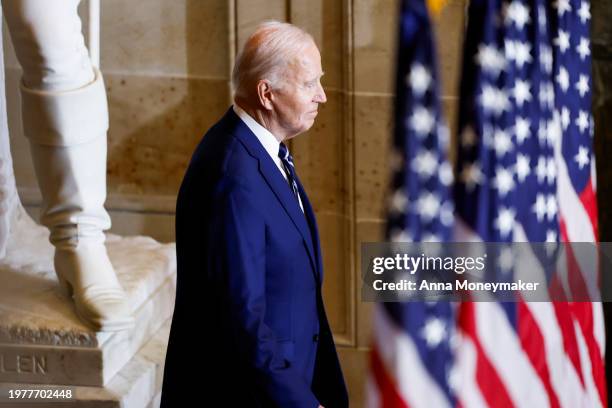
[21,70,134,331]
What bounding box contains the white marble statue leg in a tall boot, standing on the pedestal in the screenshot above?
[2,0,133,331]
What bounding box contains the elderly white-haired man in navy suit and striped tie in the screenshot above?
[162,22,348,408]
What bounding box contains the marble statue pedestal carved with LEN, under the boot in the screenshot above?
[0,210,176,407]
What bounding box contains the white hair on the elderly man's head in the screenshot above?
[232,21,315,97]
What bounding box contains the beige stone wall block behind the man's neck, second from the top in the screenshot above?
[105,74,229,196]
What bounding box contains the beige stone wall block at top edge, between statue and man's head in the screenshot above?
[100,0,229,78]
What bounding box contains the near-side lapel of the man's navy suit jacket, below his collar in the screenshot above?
[228,108,318,277]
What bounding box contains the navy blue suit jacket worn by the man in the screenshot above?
[162,108,348,408]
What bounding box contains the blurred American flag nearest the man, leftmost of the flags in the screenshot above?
[367,0,455,408]
